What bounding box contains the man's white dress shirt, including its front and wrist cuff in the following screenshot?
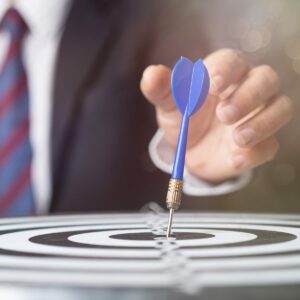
[0,0,250,214]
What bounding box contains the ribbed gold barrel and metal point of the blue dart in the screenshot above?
[166,179,183,237]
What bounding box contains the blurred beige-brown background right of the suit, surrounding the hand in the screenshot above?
[155,0,300,213]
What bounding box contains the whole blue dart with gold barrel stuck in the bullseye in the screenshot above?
[166,57,209,237]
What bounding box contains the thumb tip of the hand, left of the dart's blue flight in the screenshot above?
[140,65,176,111]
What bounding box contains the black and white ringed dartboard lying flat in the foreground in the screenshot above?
[0,213,300,299]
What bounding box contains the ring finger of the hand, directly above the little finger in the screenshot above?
[233,96,294,147]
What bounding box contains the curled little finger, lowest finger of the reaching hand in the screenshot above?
[229,137,279,173]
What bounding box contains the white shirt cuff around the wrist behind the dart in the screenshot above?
[149,129,252,196]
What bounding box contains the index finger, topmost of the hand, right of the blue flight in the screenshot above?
[204,49,250,95]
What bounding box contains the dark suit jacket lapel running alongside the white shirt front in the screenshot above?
[51,0,122,207]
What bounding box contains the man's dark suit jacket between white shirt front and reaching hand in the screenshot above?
[51,0,209,212]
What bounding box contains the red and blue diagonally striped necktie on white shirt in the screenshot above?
[0,8,34,217]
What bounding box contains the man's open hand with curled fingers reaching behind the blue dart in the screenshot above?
[141,49,294,183]
